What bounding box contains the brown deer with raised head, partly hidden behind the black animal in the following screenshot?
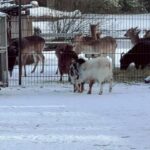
[124,27,150,46]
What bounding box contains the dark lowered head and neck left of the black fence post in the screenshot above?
[8,42,18,76]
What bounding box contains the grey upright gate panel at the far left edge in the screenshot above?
[0,13,8,87]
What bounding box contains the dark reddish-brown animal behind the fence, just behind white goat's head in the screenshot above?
[55,44,78,81]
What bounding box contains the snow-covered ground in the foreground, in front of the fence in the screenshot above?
[0,83,150,150]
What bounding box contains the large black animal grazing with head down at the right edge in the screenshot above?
[120,40,150,70]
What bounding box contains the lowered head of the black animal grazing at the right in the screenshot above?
[120,53,131,70]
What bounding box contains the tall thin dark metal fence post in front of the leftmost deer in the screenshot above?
[18,0,22,85]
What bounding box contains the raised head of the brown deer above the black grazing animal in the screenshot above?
[124,27,141,38]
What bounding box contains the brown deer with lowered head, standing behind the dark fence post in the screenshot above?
[8,35,45,77]
